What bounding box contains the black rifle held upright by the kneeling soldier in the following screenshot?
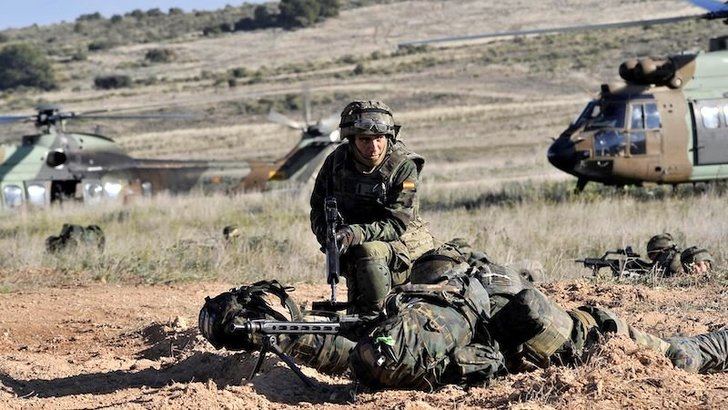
[312,196,348,312]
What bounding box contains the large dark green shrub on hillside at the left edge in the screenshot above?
[0,44,57,90]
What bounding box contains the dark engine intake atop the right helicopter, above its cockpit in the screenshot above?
[619,57,684,88]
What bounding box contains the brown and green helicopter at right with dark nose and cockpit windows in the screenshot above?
[400,0,728,192]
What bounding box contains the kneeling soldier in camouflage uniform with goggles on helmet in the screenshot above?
[311,101,434,315]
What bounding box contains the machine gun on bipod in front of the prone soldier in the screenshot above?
[229,315,367,389]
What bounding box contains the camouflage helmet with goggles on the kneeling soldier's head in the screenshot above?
[339,100,400,140]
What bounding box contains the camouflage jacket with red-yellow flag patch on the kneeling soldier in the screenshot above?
[311,141,425,244]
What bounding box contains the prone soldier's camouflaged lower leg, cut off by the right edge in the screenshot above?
[666,329,728,373]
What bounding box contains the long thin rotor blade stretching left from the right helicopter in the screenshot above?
[398,14,712,47]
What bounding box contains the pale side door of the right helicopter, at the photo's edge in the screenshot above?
[692,100,728,165]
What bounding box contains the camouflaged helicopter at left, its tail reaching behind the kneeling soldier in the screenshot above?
[0,105,340,208]
